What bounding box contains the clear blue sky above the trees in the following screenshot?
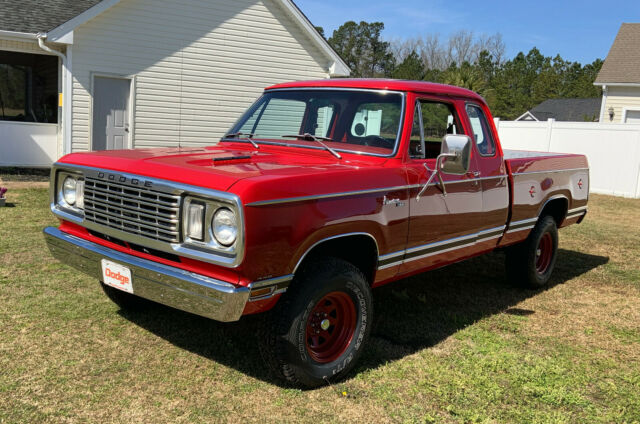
[295,0,640,63]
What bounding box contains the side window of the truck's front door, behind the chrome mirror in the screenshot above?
[409,100,462,159]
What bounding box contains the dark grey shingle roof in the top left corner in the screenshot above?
[0,0,102,34]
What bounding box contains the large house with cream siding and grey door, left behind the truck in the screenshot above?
[0,0,349,166]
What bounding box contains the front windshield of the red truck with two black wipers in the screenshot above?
[223,90,403,156]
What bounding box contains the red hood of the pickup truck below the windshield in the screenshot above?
[60,143,385,191]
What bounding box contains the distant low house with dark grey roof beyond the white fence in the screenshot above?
[516,98,602,122]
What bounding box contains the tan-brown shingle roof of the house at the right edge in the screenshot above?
[596,23,640,84]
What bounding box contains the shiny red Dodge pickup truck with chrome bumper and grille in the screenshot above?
[44,80,589,387]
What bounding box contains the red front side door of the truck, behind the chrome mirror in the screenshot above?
[400,99,482,274]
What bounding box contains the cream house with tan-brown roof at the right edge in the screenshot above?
[594,23,640,124]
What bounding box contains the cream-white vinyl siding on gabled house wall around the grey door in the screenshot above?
[72,0,331,151]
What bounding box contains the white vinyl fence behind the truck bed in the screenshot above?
[495,119,640,198]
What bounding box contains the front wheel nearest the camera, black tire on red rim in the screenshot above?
[260,258,373,388]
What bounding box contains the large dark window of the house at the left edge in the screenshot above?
[0,51,58,123]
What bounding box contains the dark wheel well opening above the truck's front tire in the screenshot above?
[297,234,378,284]
